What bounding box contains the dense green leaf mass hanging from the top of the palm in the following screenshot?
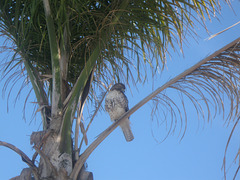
[1,0,225,87]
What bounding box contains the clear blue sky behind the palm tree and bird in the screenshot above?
[0,0,240,180]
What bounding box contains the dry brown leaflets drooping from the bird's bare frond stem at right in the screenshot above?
[151,51,240,139]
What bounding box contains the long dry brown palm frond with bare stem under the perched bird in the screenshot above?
[70,38,240,178]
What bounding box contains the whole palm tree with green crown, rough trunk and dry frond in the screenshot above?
[0,0,239,179]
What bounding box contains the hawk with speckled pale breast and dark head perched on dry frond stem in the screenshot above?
[105,83,134,142]
